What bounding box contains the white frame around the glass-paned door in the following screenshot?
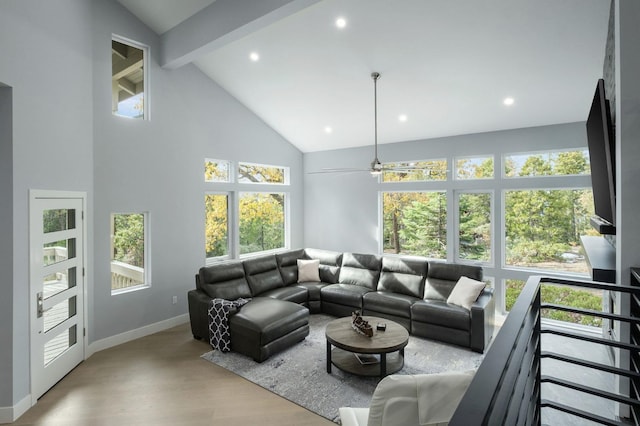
[29,189,90,406]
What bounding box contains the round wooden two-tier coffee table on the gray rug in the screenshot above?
[325,316,409,377]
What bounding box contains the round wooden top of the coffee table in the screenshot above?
[325,316,409,354]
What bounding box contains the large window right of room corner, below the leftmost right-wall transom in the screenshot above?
[382,191,447,259]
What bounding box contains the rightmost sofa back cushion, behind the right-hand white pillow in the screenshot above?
[424,262,482,301]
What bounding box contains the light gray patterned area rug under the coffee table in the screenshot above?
[202,314,483,423]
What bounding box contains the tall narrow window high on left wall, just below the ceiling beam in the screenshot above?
[111,37,149,119]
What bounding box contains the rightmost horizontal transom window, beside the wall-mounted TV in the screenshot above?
[504,150,591,178]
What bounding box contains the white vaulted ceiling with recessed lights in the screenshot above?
[119,0,609,152]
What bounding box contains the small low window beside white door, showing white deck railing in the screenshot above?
[111,213,150,294]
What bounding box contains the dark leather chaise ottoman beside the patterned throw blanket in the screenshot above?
[229,297,309,362]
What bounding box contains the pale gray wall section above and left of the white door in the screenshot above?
[0,0,93,407]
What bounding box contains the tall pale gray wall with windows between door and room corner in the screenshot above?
[90,1,302,341]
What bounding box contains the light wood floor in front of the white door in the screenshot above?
[13,324,335,426]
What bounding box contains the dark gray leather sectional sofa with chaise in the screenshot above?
[188,248,495,362]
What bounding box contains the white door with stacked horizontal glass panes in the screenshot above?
[29,191,85,404]
